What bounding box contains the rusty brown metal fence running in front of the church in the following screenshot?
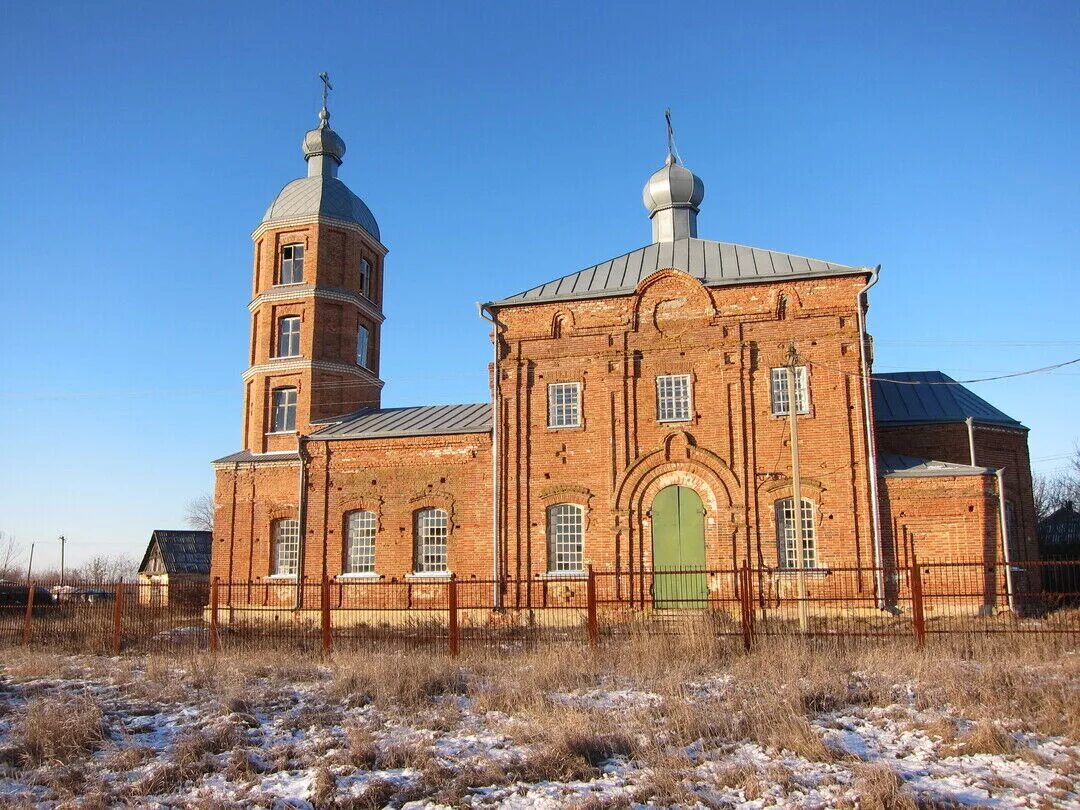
[0,561,1080,654]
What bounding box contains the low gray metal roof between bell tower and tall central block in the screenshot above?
[311,402,491,441]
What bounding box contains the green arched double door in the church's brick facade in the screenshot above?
[652,486,708,608]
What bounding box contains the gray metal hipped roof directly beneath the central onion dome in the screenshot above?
[492,239,870,306]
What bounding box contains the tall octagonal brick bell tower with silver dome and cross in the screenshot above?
[243,73,387,453]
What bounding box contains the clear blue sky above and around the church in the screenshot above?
[0,2,1080,566]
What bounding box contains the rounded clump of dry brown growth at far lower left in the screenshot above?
[12,696,106,766]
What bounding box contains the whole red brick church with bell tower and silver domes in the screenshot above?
[212,93,1036,605]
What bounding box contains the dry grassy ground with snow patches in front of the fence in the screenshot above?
[0,638,1080,808]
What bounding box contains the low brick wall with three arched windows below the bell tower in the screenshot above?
[212,434,491,600]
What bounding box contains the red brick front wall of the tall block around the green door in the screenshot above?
[498,271,872,600]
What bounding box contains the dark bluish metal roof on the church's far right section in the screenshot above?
[872,372,1026,430]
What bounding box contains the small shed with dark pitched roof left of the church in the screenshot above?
[138,529,213,605]
